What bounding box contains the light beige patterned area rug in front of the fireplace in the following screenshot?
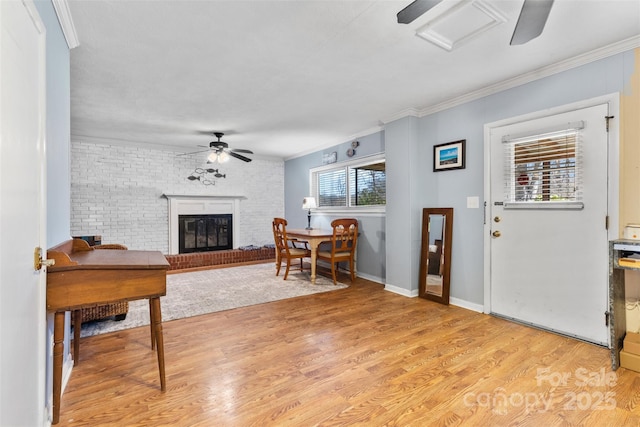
[80,262,347,337]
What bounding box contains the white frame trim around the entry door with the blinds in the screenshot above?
[483,93,620,314]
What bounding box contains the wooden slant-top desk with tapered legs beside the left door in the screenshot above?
[47,239,169,424]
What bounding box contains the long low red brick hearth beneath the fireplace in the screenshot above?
[165,247,275,270]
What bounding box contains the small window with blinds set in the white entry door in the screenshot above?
[503,123,584,209]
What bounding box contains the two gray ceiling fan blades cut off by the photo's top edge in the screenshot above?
[397,0,553,46]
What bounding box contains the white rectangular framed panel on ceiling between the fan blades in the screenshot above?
[416,0,507,52]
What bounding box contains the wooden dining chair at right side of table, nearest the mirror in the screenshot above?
[318,218,358,285]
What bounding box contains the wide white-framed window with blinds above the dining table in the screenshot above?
[310,155,387,209]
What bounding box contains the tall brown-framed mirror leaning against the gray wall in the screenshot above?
[419,208,453,305]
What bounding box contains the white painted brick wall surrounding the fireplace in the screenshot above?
[71,142,284,253]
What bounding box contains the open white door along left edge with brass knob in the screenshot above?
[0,1,46,426]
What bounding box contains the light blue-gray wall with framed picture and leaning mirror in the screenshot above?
[285,51,634,306]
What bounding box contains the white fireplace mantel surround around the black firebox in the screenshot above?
[163,194,246,255]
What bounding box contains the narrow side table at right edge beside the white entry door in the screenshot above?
[609,239,640,371]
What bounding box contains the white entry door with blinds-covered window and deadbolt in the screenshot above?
[486,104,609,345]
